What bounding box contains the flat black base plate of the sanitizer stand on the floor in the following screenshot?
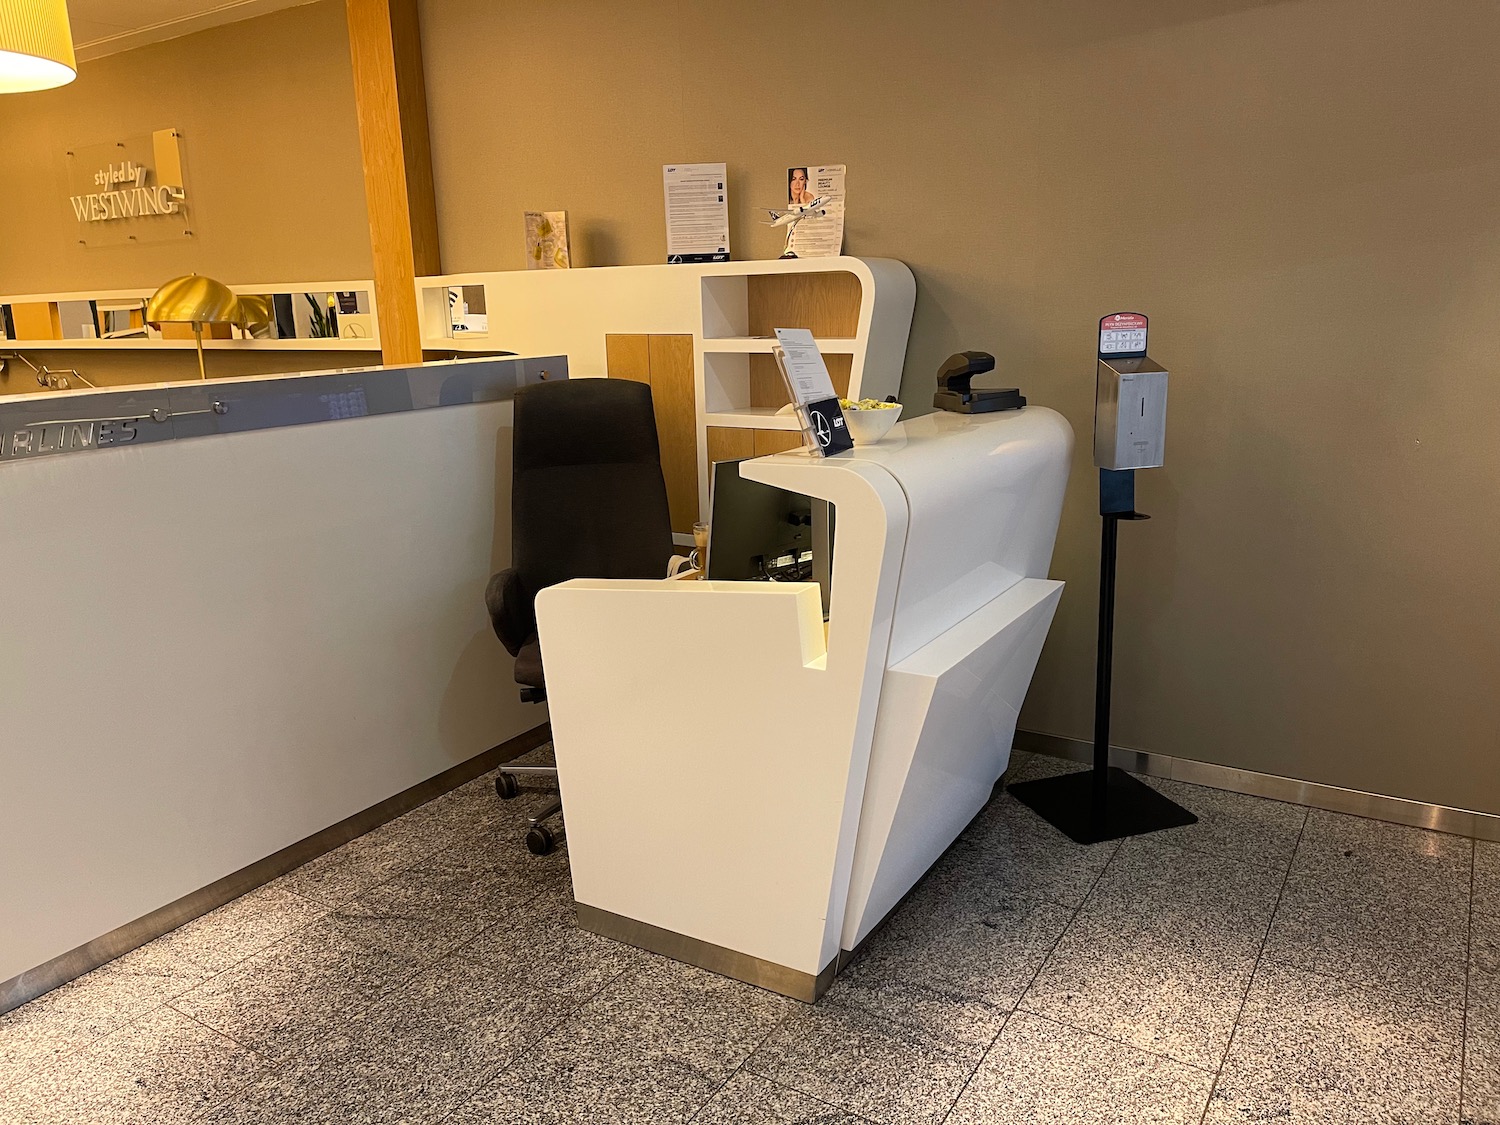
[1010,767,1199,843]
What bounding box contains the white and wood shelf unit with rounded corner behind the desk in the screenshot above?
[416,257,917,534]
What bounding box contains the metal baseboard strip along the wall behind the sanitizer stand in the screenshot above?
[1014,731,1500,840]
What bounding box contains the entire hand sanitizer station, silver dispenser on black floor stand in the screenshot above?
[1010,312,1199,845]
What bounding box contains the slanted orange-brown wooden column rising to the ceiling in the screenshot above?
[345,0,443,365]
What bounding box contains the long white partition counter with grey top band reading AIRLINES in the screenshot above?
[0,357,567,1011]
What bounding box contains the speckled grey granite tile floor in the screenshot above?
[0,749,1500,1125]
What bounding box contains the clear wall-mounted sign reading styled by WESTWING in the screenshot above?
[68,129,192,246]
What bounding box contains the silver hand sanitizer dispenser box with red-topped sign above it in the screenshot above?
[1094,312,1167,470]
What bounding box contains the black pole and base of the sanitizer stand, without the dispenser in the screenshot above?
[1010,470,1199,845]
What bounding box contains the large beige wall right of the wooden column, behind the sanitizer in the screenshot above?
[423,0,1500,812]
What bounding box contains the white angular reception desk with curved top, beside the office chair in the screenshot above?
[537,407,1073,1001]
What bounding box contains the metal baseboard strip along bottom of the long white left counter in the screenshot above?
[0,723,552,1014]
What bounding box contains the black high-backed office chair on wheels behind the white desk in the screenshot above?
[485,380,672,855]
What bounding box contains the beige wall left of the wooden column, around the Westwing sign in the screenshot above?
[0,0,372,297]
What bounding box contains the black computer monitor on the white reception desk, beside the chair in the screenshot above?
[707,461,833,614]
